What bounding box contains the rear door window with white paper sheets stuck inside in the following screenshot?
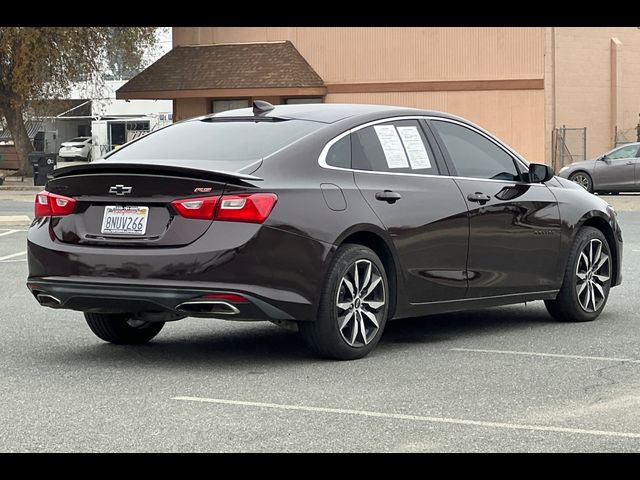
[351,120,439,175]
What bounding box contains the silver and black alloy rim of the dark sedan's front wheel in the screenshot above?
[576,238,611,313]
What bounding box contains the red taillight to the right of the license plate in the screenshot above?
[171,193,278,223]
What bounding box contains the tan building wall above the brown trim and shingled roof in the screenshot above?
[173,27,544,83]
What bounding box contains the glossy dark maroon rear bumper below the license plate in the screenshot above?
[27,220,333,320]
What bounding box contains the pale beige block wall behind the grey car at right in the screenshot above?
[545,27,640,163]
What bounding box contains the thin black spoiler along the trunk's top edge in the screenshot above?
[51,161,263,182]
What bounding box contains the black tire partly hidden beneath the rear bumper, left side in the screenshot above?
[84,313,164,345]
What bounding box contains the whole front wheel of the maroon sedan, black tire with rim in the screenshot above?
[544,227,613,322]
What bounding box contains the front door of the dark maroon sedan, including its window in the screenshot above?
[429,119,560,298]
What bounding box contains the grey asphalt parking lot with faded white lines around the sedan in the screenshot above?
[0,196,640,452]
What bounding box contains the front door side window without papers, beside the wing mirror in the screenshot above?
[431,120,520,181]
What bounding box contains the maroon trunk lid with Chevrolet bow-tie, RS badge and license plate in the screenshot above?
[47,161,260,247]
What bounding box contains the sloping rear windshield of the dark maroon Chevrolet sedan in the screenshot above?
[108,120,324,162]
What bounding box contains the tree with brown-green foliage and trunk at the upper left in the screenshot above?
[0,27,156,174]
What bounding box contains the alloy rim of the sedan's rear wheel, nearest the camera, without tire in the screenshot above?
[336,260,386,347]
